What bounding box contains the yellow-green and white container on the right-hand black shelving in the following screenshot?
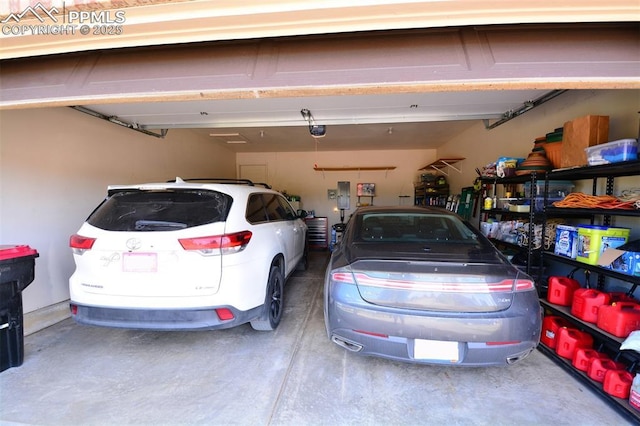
[576,225,630,265]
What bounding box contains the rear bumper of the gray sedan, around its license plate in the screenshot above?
[325,284,542,366]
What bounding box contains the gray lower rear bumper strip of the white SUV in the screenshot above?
[71,302,262,330]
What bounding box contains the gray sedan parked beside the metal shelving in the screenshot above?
[324,206,542,366]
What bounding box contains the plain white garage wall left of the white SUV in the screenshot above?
[0,108,236,330]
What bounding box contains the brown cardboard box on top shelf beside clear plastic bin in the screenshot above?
[560,115,609,168]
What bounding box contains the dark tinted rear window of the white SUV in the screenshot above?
[87,189,233,231]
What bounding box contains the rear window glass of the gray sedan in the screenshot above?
[356,213,477,243]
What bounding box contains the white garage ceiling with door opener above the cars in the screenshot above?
[75,90,547,152]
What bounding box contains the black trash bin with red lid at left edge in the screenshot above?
[0,245,39,371]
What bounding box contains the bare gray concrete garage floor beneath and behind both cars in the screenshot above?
[0,252,629,426]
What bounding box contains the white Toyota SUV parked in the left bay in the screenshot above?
[69,178,307,330]
